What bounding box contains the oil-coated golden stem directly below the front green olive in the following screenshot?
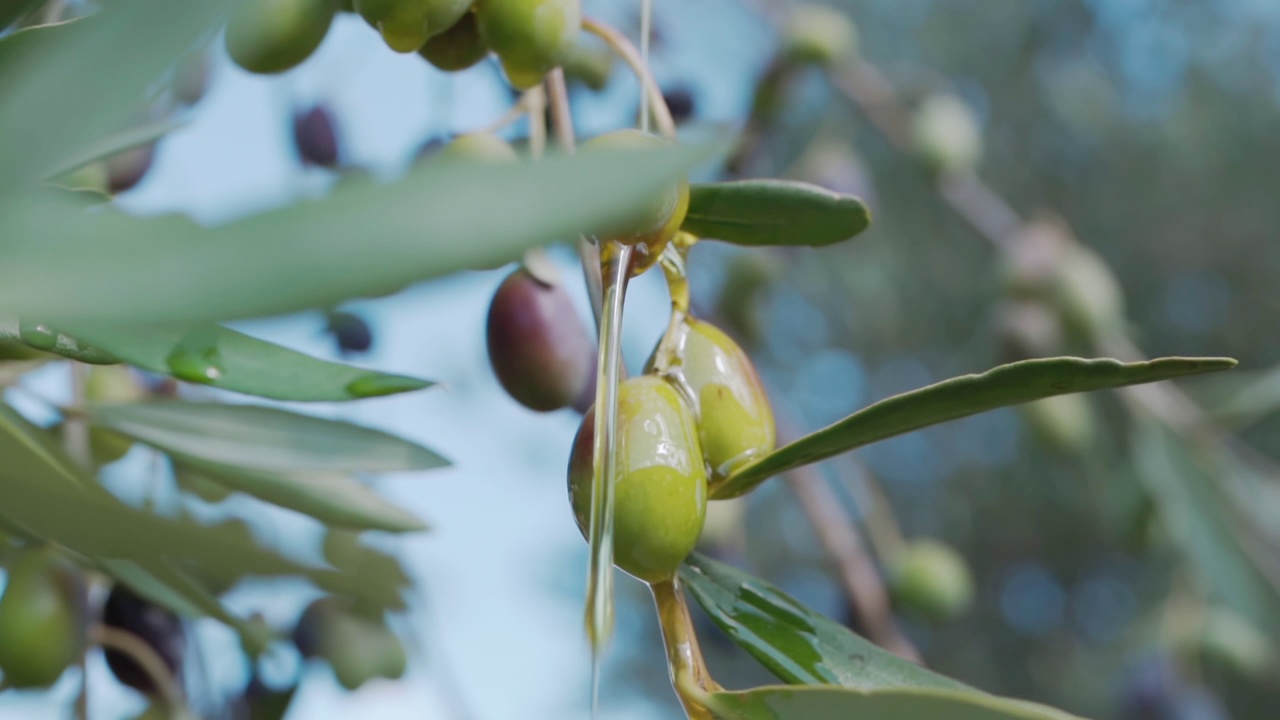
[649,578,721,720]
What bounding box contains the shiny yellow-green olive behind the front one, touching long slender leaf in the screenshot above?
[672,318,777,479]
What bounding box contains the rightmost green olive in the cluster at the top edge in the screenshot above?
[476,0,582,90]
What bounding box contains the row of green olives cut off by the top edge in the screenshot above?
[227,0,581,90]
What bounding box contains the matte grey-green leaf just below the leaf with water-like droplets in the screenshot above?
[87,401,448,473]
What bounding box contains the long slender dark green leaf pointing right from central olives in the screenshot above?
[712,357,1235,498]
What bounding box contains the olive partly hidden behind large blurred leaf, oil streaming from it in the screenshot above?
[582,129,689,266]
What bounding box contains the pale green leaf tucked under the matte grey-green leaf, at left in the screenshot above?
[170,452,426,533]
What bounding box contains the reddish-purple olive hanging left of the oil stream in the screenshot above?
[488,268,595,413]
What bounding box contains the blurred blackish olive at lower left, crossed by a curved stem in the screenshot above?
[102,585,187,694]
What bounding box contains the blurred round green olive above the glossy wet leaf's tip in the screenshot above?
[888,539,974,621]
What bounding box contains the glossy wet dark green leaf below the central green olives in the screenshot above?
[680,553,968,691]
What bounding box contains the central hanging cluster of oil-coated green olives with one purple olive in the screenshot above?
[488,131,776,582]
